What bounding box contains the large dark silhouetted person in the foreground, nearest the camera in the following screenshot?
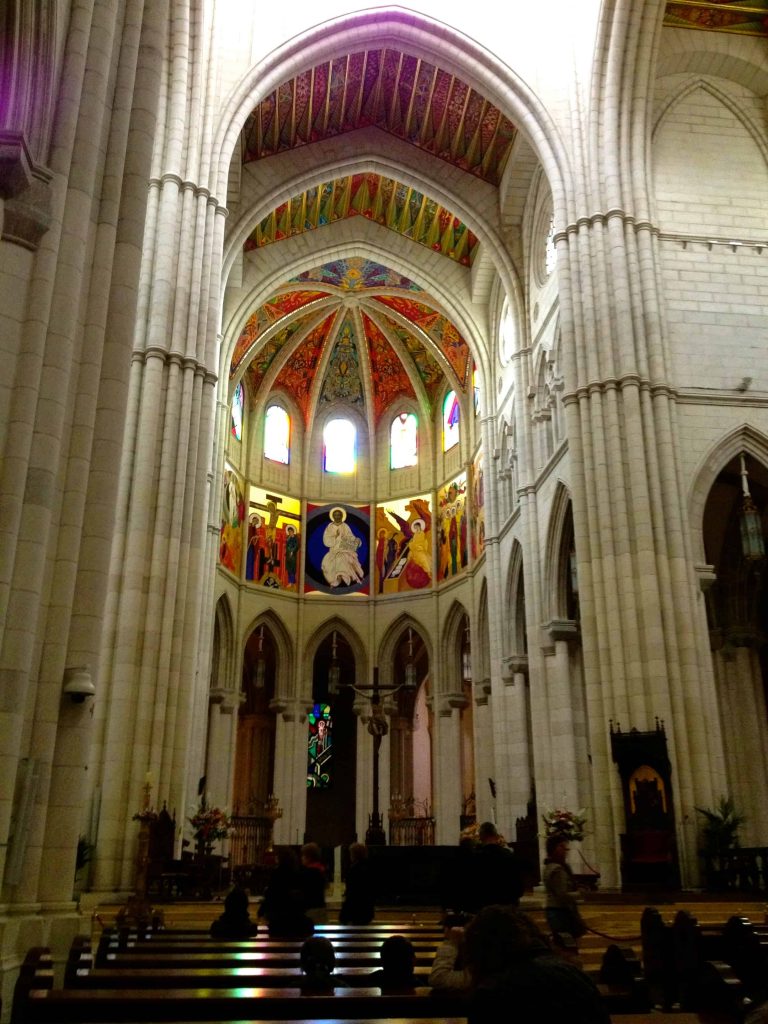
[465,905,610,1024]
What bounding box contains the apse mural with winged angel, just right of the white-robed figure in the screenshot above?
[374,495,434,594]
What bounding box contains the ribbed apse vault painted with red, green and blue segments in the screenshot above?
[230,258,472,426]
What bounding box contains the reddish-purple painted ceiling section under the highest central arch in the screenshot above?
[243,47,516,185]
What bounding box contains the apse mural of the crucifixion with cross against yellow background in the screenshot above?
[246,486,301,593]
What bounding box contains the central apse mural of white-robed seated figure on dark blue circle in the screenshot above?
[304,504,371,594]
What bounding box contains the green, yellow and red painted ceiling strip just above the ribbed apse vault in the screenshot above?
[244,174,477,266]
